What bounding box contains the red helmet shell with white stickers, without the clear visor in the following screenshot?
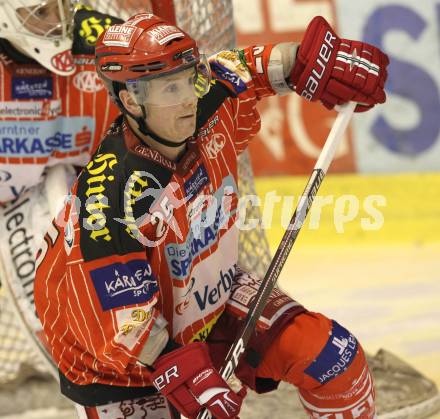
[95,13,208,106]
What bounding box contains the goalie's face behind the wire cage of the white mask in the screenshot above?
[17,0,69,36]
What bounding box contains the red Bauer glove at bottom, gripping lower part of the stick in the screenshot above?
[153,342,245,419]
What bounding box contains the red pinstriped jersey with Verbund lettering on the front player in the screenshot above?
[35,46,288,386]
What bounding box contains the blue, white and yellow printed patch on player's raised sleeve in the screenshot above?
[209,49,252,94]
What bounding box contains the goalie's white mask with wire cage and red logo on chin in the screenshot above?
[0,0,75,76]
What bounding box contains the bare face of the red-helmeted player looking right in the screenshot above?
[145,68,198,142]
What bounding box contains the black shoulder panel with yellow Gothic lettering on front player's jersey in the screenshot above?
[77,117,172,260]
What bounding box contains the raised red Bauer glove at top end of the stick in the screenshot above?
[290,16,389,112]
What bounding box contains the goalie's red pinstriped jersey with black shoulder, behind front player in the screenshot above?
[0,9,119,203]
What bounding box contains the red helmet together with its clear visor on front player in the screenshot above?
[96,13,211,113]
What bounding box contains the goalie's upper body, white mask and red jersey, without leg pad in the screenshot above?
[0,0,120,203]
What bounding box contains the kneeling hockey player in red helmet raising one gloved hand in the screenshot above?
[35,14,388,419]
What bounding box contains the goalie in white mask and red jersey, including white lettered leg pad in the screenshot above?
[0,0,119,324]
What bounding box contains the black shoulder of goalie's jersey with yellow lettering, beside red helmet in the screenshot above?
[72,6,123,55]
